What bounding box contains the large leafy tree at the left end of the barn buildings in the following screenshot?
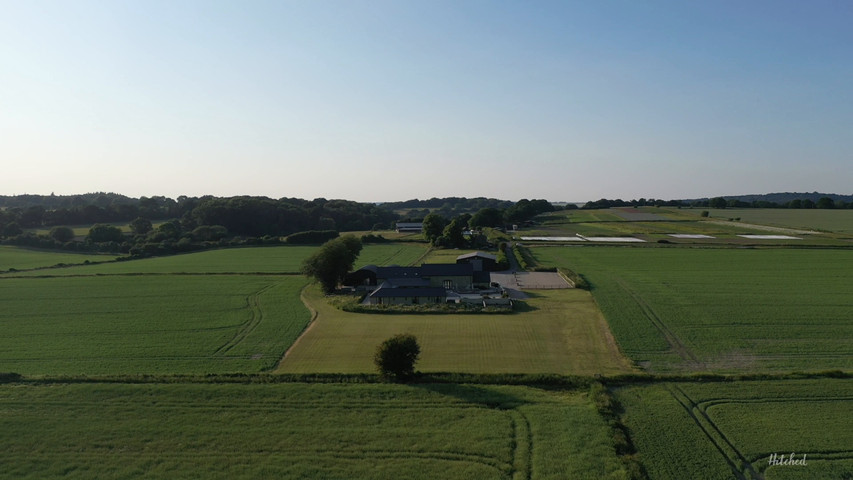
[302,235,361,293]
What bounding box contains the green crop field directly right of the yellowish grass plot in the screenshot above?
[531,247,853,372]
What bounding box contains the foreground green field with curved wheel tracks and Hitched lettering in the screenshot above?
[617,379,853,480]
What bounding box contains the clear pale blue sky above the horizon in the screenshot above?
[0,0,853,202]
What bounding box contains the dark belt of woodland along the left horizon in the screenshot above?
[0,194,397,255]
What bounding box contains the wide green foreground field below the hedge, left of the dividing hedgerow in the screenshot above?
[0,383,624,480]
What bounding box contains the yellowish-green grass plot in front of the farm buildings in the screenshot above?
[277,288,630,375]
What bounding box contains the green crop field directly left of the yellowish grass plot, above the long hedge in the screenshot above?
[0,275,310,375]
